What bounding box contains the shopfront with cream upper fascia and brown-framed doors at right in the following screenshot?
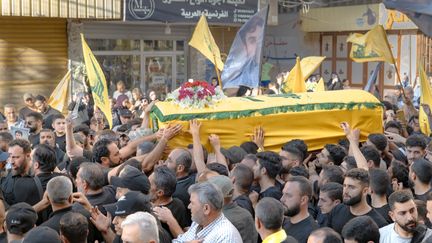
[301,4,421,92]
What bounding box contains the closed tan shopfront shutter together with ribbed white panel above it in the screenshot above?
[0,0,122,106]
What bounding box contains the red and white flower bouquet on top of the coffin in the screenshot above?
[166,80,226,109]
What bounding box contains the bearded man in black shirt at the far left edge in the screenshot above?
[1,139,42,205]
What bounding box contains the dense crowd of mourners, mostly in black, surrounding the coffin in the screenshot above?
[0,77,432,243]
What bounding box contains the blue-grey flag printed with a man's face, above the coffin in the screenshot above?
[222,7,268,96]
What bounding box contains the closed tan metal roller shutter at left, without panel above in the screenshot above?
[0,17,68,106]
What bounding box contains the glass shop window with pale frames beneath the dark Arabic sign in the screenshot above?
[70,22,191,98]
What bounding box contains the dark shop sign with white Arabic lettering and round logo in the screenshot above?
[125,0,259,24]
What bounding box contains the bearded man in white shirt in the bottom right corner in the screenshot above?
[380,190,432,243]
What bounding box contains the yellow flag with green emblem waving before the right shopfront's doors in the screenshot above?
[347,25,395,64]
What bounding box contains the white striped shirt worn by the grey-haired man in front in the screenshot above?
[172,213,243,243]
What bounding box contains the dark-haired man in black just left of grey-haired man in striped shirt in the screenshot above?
[149,166,192,237]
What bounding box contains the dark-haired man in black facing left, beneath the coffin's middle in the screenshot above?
[249,151,282,205]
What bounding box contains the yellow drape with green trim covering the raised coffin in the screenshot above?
[151,90,383,151]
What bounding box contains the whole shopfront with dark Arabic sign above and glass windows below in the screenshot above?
[68,0,264,98]
